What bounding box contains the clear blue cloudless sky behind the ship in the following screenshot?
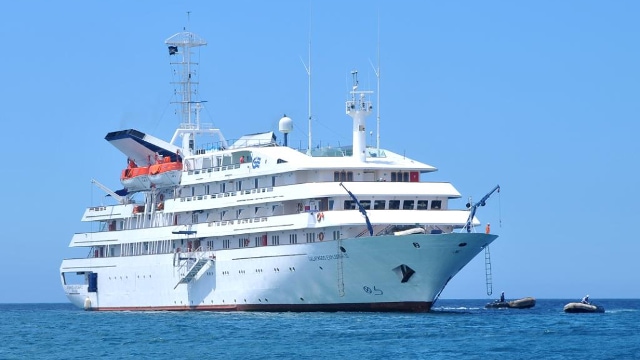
[0,0,640,303]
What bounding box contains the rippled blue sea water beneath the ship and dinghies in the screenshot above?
[0,299,640,360]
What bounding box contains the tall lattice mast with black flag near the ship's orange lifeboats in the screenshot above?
[165,25,228,155]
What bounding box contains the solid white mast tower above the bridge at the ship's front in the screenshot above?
[346,71,373,162]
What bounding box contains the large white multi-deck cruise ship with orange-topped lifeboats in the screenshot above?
[60,30,499,312]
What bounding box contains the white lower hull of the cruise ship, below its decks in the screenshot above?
[61,233,497,311]
